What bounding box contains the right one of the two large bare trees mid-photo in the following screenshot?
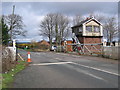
[54,13,70,45]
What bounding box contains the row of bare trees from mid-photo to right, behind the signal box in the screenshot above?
[39,13,118,46]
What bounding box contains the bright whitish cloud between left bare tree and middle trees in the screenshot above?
[17,7,44,40]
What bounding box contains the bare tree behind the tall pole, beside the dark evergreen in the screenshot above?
[4,14,26,38]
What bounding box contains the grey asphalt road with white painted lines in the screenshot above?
[13,51,118,88]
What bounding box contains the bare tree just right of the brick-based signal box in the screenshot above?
[104,16,118,42]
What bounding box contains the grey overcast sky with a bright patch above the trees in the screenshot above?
[2,2,118,40]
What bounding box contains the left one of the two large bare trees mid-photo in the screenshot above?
[39,14,54,49]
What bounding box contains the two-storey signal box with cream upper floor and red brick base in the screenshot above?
[72,17,103,53]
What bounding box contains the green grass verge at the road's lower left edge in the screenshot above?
[2,61,26,90]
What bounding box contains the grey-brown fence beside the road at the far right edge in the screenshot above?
[103,46,120,59]
